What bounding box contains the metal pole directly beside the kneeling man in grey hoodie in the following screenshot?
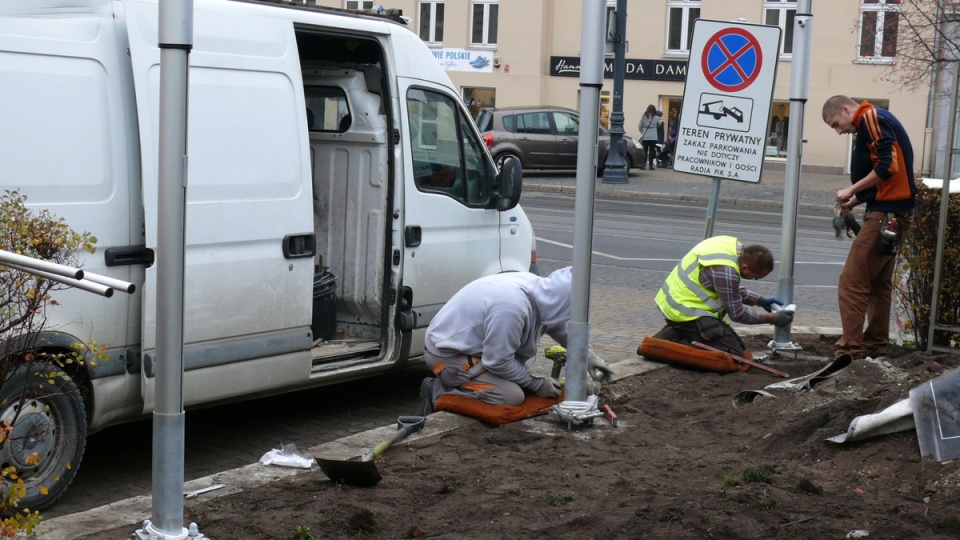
[566,0,607,401]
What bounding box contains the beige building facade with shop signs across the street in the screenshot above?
[316,0,934,173]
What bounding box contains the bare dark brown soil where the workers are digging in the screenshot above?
[80,336,960,540]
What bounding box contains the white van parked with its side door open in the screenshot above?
[0,0,533,509]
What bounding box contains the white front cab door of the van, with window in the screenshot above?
[399,78,501,336]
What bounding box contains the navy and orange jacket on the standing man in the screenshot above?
[850,101,917,212]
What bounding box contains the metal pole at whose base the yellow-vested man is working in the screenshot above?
[773,0,813,349]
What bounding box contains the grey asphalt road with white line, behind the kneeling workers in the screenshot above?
[523,192,850,326]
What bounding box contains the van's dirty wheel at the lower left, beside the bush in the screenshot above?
[0,363,87,511]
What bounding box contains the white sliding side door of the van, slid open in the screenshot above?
[123,0,313,412]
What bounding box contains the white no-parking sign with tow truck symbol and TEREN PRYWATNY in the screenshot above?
[673,19,780,183]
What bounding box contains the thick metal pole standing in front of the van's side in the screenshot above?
[136,0,196,540]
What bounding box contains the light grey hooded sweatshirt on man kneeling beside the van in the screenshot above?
[426,266,572,391]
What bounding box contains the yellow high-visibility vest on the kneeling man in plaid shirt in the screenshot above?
[655,236,740,322]
